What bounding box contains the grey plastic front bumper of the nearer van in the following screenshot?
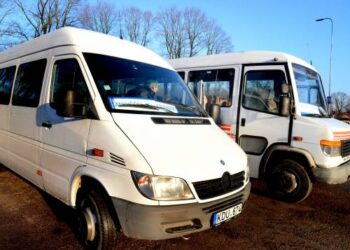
[113,182,251,240]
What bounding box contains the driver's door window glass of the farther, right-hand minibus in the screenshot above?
[243,70,286,114]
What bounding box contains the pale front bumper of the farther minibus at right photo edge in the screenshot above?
[312,161,350,184]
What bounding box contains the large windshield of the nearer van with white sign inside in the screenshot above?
[84,53,207,116]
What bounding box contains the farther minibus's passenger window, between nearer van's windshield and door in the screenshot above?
[188,69,235,107]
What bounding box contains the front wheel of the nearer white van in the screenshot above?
[77,189,117,249]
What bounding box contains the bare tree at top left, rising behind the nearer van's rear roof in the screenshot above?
[5,0,80,40]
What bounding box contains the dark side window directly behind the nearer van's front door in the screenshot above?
[12,59,46,107]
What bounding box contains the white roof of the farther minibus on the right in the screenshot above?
[169,51,316,71]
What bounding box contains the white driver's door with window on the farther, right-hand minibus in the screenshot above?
[237,64,290,178]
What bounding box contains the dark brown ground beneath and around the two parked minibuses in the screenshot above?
[0,166,350,250]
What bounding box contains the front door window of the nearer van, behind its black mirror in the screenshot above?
[50,59,89,108]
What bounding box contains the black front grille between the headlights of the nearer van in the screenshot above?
[193,171,244,199]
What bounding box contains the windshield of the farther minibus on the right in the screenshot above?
[293,64,327,117]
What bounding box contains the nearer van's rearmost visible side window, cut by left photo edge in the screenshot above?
[0,66,16,105]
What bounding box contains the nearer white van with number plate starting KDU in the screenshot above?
[0,28,250,249]
